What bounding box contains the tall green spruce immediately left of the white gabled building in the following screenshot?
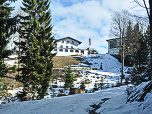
[17,0,55,100]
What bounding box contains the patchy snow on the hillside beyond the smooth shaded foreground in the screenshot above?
[0,54,129,99]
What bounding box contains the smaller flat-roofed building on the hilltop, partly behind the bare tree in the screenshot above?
[106,38,121,55]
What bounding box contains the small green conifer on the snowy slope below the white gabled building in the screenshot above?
[65,67,74,87]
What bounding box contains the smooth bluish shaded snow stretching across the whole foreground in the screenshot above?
[0,82,152,114]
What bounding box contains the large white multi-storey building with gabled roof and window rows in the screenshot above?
[52,37,88,56]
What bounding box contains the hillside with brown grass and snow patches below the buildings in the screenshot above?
[1,54,128,100]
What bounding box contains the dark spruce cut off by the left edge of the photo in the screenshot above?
[0,0,17,90]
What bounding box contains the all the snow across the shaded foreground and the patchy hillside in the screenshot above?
[0,54,152,114]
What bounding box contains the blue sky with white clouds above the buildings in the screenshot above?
[8,0,148,53]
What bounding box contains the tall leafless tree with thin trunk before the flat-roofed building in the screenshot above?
[110,10,130,84]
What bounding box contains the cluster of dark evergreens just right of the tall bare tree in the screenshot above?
[124,21,148,69]
